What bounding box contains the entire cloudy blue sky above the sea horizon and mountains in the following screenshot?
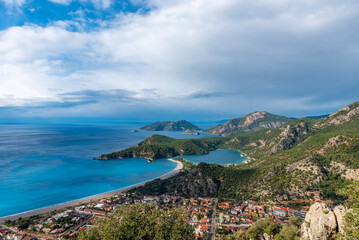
[0,0,359,122]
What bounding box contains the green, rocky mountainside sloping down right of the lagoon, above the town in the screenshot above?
[129,102,359,201]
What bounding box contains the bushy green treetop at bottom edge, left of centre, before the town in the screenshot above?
[78,204,194,240]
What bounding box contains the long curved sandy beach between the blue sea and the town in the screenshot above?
[0,159,183,224]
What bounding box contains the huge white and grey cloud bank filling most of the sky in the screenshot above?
[0,0,359,118]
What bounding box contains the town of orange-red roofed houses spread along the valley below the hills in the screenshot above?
[0,191,320,240]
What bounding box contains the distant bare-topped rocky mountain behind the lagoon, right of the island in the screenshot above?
[207,112,293,136]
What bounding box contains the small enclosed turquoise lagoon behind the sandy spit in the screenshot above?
[182,149,247,165]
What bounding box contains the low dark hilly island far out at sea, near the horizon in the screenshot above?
[140,120,201,131]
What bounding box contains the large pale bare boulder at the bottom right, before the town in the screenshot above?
[301,202,337,240]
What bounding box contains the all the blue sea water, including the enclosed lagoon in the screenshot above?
[0,124,245,217]
